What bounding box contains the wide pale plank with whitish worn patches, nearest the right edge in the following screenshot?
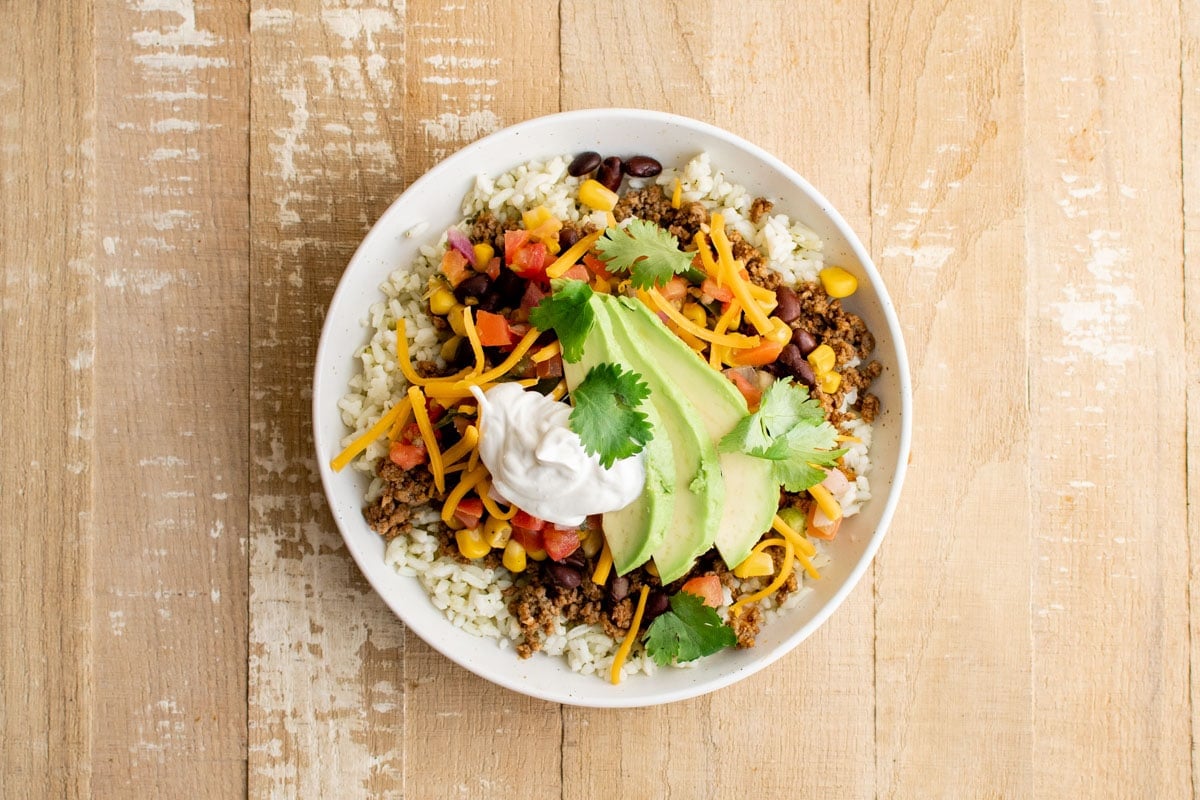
[1022,2,1190,798]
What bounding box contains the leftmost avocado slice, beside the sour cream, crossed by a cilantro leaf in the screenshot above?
[563,295,676,575]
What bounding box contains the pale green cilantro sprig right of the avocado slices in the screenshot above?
[720,380,846,492]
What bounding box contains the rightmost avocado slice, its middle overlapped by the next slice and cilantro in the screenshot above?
[607,297,779,570]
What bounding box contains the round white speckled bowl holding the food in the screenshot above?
[313,109,912,706]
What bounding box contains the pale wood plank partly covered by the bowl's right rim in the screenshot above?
[870,0,1037,798]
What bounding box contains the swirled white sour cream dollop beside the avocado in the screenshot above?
[472,383,646,527]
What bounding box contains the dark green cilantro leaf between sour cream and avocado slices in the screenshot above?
[569,361,653,468]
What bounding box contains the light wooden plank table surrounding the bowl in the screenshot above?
[0,0,1200,799]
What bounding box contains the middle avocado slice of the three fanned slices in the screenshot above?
[598,295,726,584]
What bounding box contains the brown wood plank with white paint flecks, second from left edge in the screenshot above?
[92,0,248,798]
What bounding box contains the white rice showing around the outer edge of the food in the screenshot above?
[338,154,871,679]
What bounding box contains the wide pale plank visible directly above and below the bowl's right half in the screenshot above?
[562,1,875,798]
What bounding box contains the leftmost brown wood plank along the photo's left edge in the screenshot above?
[0,2,96,798]
